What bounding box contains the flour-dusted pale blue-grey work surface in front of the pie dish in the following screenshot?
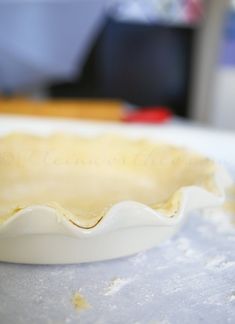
[0,205,235,324]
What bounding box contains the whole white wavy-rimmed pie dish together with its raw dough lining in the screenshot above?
[0,133,231,264]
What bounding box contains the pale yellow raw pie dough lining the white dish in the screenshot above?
[0,134,215,228]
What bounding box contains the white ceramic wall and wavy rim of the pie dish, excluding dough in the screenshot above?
[0,116,232,264]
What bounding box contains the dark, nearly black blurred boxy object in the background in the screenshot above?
[50,18,194,116]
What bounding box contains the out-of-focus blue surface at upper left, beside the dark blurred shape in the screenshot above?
[0,0,108,93]
